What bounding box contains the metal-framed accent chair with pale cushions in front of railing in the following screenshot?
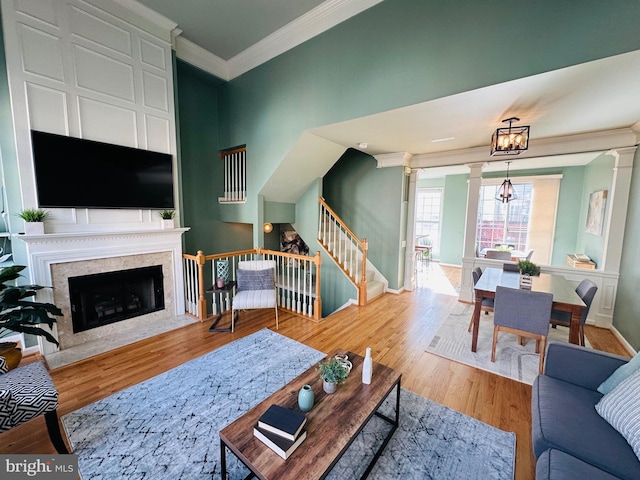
[231,260,279,332]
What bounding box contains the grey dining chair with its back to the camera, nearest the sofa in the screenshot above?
[491,286,553,374]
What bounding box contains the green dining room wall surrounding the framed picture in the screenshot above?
[576,154,614,266]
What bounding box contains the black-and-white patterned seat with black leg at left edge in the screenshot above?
[0,356,69,453]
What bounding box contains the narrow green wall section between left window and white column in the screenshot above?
[440,175,469,265]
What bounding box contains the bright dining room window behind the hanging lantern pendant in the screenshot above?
[476,183,533,252]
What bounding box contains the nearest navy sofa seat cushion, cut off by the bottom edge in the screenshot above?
[536,448,618,480]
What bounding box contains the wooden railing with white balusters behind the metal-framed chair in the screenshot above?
[182,248,322,322]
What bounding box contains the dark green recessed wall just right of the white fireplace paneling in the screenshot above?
[176,60,253,254]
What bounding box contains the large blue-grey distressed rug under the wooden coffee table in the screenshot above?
[62,329,515,480]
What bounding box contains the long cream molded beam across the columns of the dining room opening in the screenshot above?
[410,128,637,168]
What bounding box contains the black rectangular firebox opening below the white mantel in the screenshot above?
[69,265,164,333]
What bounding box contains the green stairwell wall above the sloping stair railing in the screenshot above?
[323,149,406,289]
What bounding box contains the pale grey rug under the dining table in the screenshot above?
[426,303,590,385]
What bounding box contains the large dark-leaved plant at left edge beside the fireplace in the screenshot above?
[0,265,62,368]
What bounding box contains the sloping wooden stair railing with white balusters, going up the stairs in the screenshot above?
[318,197,368,306]
